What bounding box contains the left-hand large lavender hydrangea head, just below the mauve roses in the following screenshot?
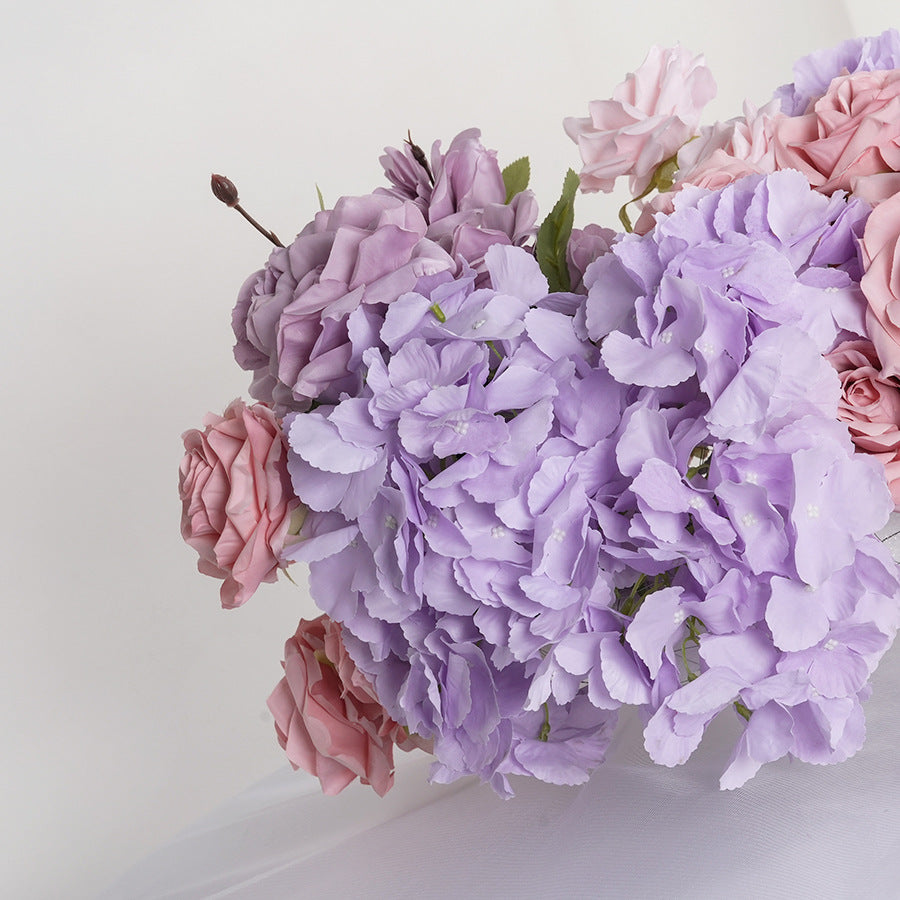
[285,246,618,794]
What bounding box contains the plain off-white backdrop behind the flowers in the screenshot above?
[0,0,900,898]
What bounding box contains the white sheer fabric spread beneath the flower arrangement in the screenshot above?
[104,515,900,900]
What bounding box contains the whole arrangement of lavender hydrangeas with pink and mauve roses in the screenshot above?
[180,31,900,796]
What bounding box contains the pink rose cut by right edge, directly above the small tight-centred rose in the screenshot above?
[860,194,900,377]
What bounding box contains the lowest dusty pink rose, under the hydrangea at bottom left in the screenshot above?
[269,615,425,796]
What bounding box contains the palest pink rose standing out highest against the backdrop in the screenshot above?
[563,46,716,196]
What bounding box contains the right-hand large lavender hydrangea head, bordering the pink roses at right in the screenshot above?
[583,172,900,787]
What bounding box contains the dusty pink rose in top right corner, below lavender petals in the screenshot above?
[773,70,900,194]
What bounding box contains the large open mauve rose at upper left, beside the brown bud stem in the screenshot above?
[231,194,455,415]
